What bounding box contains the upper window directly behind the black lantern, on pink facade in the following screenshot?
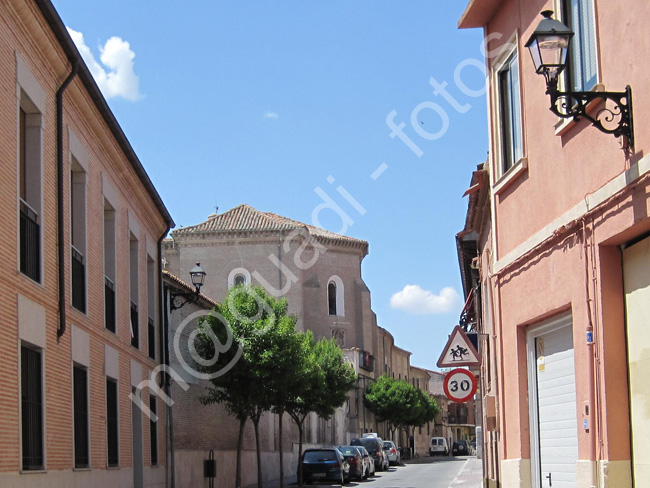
[562,0,598,91]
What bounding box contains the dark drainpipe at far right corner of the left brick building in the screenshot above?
[157,230,176,488]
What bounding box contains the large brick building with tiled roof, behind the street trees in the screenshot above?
[163,205,442,486]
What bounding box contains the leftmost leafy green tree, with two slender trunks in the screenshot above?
[195,286,296,488]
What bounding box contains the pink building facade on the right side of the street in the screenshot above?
[459,0,650,488]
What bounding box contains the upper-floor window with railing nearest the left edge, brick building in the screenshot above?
[18,98,42,283]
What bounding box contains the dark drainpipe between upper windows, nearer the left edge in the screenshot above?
[56,58,79,343]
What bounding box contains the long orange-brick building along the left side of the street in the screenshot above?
[0,0,173,487]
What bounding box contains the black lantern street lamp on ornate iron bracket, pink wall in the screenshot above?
[526,10,634,148]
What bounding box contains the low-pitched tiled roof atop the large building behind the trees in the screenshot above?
[173,203,368,245]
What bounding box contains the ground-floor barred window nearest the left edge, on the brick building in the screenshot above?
[20,345,45,471]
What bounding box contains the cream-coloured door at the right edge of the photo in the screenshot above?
[623,237,650,487]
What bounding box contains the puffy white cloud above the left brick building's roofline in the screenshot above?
[67,27,142,101]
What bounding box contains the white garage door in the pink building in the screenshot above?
[528,316,578,488]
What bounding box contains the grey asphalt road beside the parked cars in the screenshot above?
[294,456,481,488]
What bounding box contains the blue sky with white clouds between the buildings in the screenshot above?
[53,0,487,369]
